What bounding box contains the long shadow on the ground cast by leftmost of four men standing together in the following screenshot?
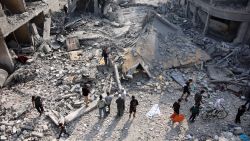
[83,119,104,141]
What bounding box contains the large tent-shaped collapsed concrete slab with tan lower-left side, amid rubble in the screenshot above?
[123,14,211,72]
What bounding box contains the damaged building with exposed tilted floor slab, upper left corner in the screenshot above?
[0,0,59,76]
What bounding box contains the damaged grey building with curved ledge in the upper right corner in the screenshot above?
[185,0,250,43]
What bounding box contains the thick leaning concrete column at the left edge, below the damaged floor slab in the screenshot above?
[0,29,14,73]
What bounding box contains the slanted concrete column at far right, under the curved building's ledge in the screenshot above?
[233,22,249,43]
